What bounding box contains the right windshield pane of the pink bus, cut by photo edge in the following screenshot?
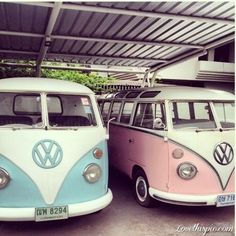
[214,102,235,128]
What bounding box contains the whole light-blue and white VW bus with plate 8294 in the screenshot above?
[0,78,112,221]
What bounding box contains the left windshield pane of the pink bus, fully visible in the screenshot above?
[170,101,216,129]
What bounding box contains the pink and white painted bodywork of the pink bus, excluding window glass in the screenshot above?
[99,86,235,206]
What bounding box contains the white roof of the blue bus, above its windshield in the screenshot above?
[0,77,93,94]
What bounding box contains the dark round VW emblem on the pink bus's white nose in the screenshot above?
[214,143,234,165]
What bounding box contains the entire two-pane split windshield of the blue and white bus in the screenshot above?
[0,92,96,128]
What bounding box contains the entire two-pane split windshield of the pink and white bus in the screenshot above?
[170,101,234,130]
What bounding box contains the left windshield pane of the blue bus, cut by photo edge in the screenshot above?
[0,92,41,128]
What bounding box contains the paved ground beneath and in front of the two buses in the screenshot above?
[0,167,234,236]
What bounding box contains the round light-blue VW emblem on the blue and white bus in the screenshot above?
[32,139,63,169]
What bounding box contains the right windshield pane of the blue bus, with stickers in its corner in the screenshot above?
[47,94,96,127]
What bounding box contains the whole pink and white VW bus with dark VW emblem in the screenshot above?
[99,86,235,207]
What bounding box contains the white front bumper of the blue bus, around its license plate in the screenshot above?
[0,189,112,221]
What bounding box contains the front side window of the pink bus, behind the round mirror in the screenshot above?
[134,103,165,129]
